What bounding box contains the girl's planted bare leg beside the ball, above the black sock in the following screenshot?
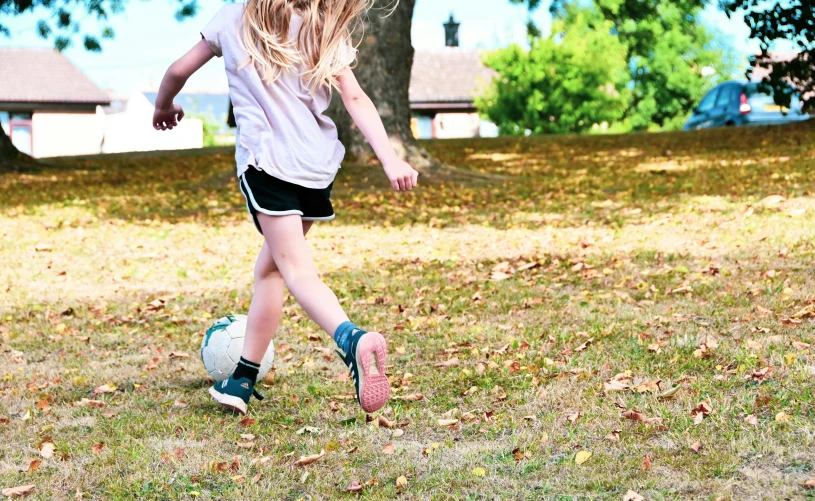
[241,221,313,363]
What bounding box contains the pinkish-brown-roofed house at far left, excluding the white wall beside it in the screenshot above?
[0,48,110,157]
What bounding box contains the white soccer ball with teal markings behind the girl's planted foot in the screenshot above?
[201,315,274,381]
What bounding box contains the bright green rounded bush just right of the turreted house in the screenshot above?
[477,7,629,134]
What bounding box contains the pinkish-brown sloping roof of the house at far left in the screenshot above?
[0,48,110,104]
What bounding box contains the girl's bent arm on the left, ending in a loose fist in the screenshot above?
[153,40,215,130]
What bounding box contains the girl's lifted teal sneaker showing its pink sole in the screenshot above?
[337,330,391,413]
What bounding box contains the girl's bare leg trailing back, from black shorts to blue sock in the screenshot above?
[250,214,348,337]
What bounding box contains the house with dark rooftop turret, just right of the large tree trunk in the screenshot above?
[409,15,498,139]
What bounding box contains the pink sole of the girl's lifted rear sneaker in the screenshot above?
[355,332,391,413]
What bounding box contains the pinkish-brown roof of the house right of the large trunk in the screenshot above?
[410,47,496,103]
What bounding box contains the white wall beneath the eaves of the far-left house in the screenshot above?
[31,111,102,158]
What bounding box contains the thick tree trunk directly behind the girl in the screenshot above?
[327,0,436,168]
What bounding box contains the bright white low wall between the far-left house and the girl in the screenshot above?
[102,92,204,153]
